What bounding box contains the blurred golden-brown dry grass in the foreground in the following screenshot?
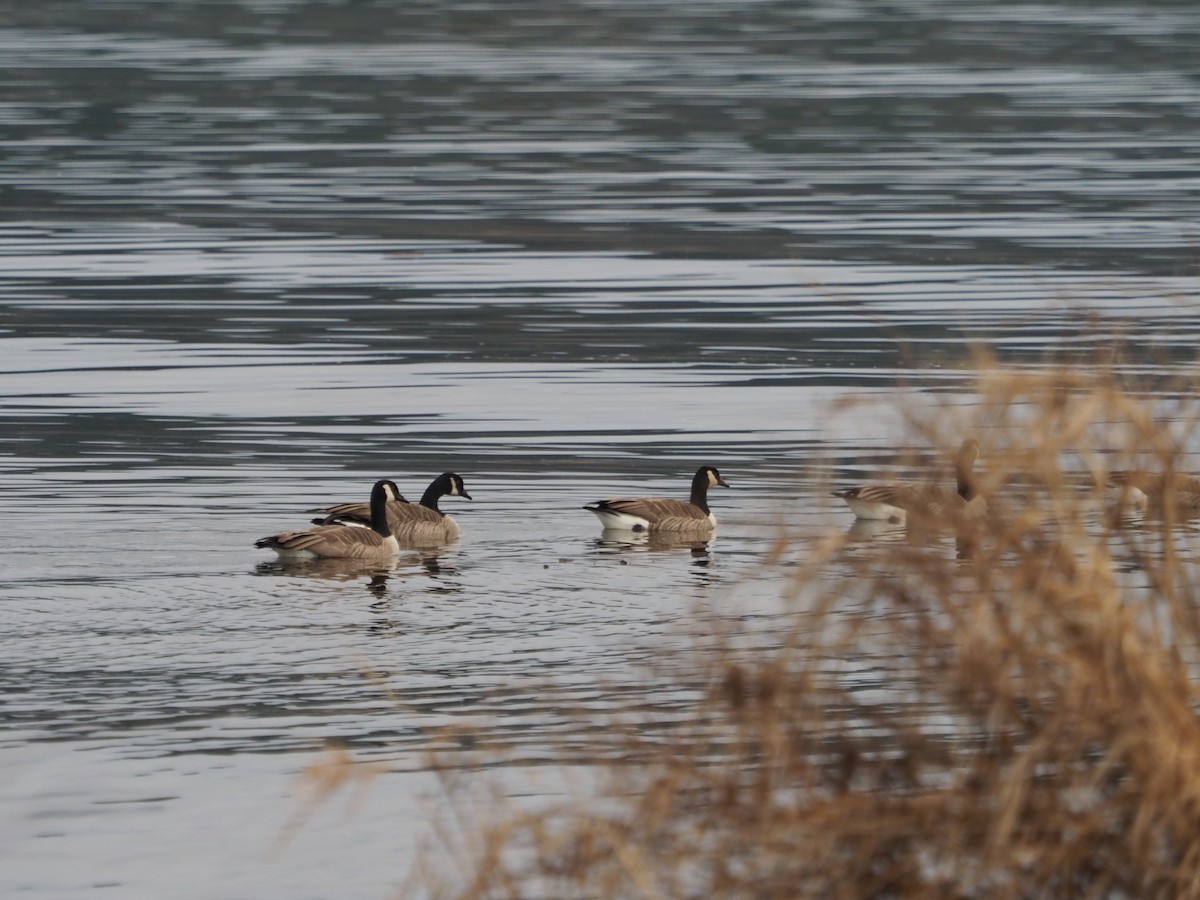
[421,368,1200,900]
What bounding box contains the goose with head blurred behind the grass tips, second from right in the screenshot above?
[833,438,986,522]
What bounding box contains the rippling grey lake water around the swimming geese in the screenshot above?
[0,0,1200,900]
